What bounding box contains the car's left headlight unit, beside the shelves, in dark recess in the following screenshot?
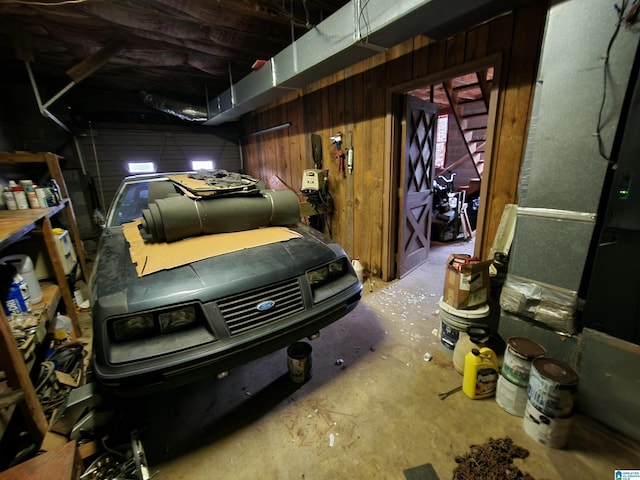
[111,305,200,342]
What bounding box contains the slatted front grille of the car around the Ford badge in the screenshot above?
[217,280,304,335]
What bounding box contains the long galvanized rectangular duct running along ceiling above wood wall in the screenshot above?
[204,0,529,125]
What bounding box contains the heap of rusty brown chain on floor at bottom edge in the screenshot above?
[453,437,534,480]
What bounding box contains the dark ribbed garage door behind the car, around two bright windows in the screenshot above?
[73,129,242,212]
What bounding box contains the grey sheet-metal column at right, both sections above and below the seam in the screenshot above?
[510,0,639,291]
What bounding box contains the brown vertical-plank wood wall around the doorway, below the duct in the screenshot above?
[241,2,547,280]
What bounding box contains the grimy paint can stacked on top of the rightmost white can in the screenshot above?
[527,357,579,418]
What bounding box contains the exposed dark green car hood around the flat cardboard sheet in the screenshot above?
[91,224,344,318]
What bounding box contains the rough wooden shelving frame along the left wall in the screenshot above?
[0,152,88,445]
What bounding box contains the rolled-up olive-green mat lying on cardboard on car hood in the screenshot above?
[142,190,300,242]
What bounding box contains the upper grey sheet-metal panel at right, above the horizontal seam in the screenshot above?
[519,0,638,212]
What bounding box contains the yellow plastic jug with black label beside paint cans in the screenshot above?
[462,347,500,399]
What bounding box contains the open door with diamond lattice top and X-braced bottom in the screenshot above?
[398,95,438,277]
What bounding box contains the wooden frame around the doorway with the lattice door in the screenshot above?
[381,53,503,281]
